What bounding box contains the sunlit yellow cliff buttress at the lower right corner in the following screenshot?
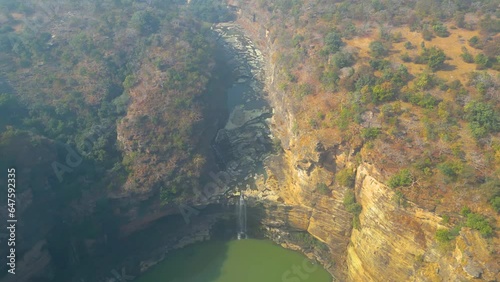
[347,164,499,281]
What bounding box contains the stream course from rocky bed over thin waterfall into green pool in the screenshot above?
[131,23,331,282]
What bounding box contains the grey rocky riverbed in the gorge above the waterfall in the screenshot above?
[212,23,273,192]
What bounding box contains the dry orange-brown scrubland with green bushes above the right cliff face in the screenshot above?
[245,1,500,256]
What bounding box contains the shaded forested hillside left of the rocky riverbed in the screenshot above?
[0,1,224,281]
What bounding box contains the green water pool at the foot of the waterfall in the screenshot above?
[134,239,332,282]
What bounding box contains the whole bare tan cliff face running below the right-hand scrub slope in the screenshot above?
[230,1,500,281]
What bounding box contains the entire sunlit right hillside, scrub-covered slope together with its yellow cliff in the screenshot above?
[230,1,500,281]
